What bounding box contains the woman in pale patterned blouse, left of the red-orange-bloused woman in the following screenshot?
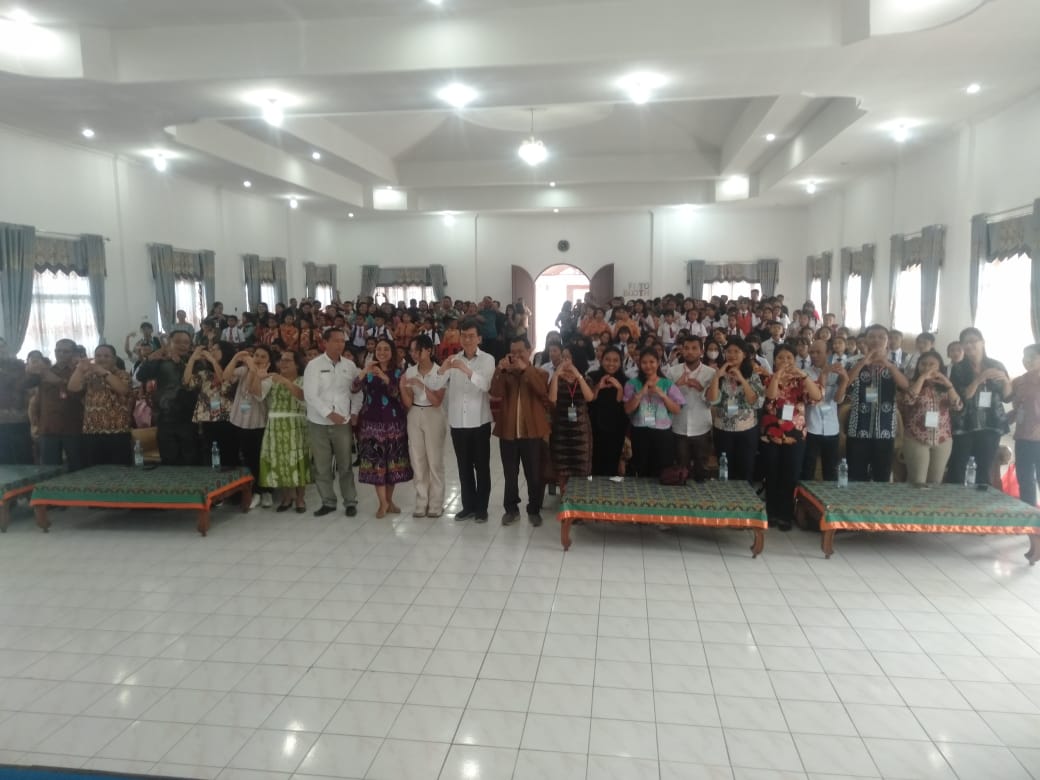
[704,336,765,480]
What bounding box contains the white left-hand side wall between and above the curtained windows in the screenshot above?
[0,128,343,342]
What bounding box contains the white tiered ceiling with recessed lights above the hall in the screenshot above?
[0,0,1040,218]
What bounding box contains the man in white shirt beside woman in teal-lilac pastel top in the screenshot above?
[665,336,714,483]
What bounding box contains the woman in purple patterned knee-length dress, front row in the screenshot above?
[354,337,413,517]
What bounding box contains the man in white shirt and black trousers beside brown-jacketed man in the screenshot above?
[438,317,495,523]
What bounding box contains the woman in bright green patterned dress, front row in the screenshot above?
[260,352,311,515]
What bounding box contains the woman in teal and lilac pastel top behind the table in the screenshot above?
[624,349,686,477]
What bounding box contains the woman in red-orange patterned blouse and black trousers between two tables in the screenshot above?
[758,344,824,530]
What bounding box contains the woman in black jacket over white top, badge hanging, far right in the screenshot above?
[946,328,1011,485]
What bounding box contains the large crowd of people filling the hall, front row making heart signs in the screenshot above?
[0,293,1040,529]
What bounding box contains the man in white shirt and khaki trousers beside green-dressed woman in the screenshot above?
[304,328,361,517]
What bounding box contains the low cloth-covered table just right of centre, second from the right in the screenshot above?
[556,476,769,557]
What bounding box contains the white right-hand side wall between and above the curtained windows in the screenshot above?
[803,86,1040,343]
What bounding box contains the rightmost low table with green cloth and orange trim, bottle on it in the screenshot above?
[796,482,1040,566]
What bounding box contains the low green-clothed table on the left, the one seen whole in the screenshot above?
[30,466,253,536]
